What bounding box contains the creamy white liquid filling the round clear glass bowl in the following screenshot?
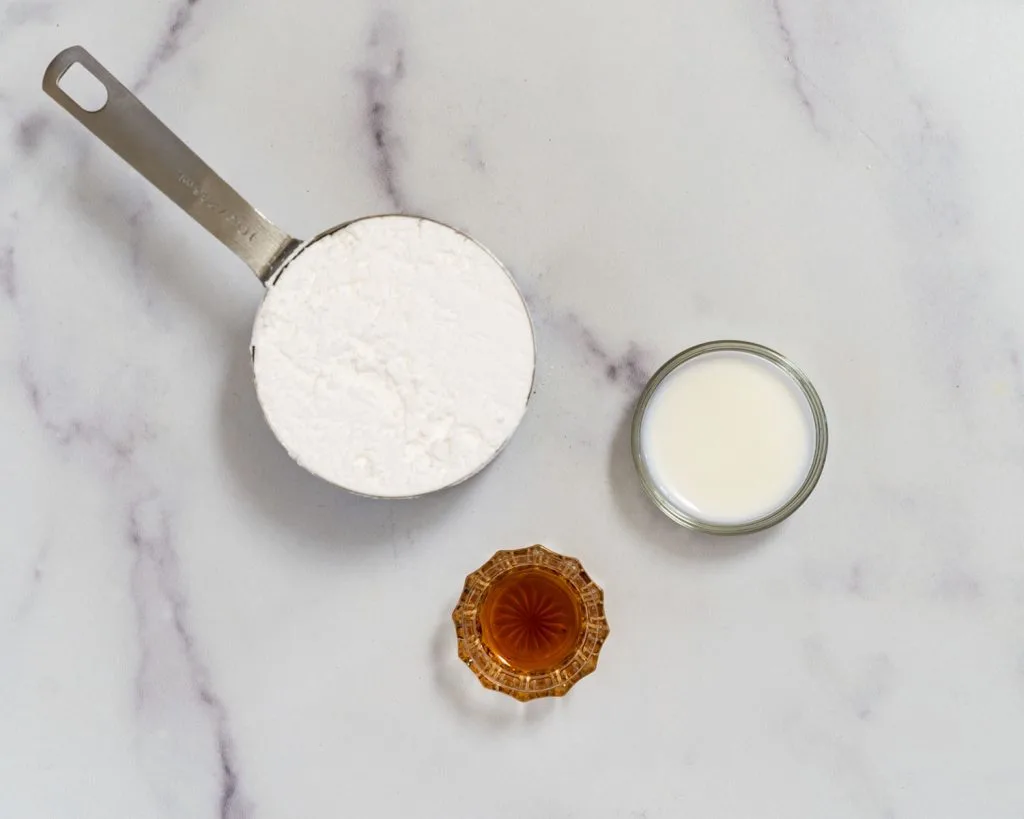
[640,351,815,524]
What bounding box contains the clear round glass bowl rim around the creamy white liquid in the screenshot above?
[631,341,828,534]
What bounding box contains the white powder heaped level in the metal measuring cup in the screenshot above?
[252,216,535,498]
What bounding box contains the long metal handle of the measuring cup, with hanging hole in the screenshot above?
[43,46,300,285]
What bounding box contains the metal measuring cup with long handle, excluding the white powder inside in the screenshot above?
[43,46,536,498]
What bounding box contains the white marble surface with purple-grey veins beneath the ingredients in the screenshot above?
[0,0,1024,819]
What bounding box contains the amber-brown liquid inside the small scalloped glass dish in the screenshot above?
[480,567,583,674]
